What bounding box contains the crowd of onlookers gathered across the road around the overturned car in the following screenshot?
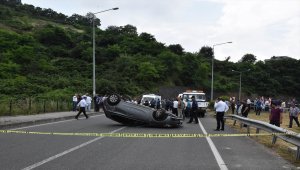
[73,93,300,131]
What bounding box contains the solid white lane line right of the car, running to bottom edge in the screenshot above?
[197,118,228,170]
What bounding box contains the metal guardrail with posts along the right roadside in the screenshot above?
[224,115,300,160]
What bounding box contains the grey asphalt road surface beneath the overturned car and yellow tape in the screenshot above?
[0,115,295,170]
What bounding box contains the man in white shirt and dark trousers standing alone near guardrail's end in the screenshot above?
[215,97,229,131]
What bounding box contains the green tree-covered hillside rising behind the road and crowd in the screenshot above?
[0,0,300,99]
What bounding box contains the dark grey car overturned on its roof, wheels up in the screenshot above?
[103,94,182,127]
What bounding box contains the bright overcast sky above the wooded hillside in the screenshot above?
[22,0,300,62]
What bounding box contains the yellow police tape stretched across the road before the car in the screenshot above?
[0,130,287,138]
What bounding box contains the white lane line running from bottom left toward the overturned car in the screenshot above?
[22,127,126,170]
